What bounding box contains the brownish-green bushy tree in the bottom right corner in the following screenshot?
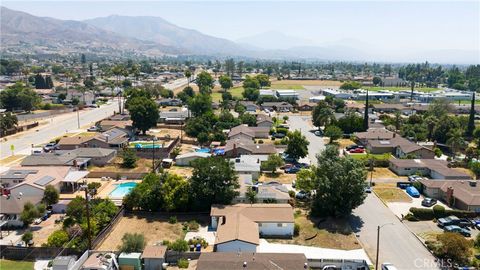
[434,232,473,265]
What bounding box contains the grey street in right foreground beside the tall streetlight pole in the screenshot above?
[350,194,438,270]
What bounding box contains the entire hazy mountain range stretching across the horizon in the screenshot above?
[0,7,479,63]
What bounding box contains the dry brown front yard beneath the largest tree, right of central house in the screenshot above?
[269,210,361,250]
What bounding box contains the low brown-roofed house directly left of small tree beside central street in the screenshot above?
[225,139,277,157]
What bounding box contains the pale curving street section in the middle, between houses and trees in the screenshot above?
[289,115,325,164]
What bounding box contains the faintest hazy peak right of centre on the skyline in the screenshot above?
[236,31,316,50]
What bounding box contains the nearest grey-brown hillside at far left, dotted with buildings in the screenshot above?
[0,7,180,54]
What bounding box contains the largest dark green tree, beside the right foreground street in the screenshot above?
[312,145,367,217]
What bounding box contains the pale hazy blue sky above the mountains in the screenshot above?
[1,0,480,57]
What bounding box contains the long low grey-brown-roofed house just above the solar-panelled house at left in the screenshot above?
[20,148,117,168]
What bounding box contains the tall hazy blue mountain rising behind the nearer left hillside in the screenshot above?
[84,15,248,56]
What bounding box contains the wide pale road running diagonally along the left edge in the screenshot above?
[0,100,118,159]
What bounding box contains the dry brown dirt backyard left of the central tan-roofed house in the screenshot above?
[97,214,208,250]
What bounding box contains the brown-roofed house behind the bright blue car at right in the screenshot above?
[389,159,472,180]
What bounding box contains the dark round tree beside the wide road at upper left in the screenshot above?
[127,97,159,134]
